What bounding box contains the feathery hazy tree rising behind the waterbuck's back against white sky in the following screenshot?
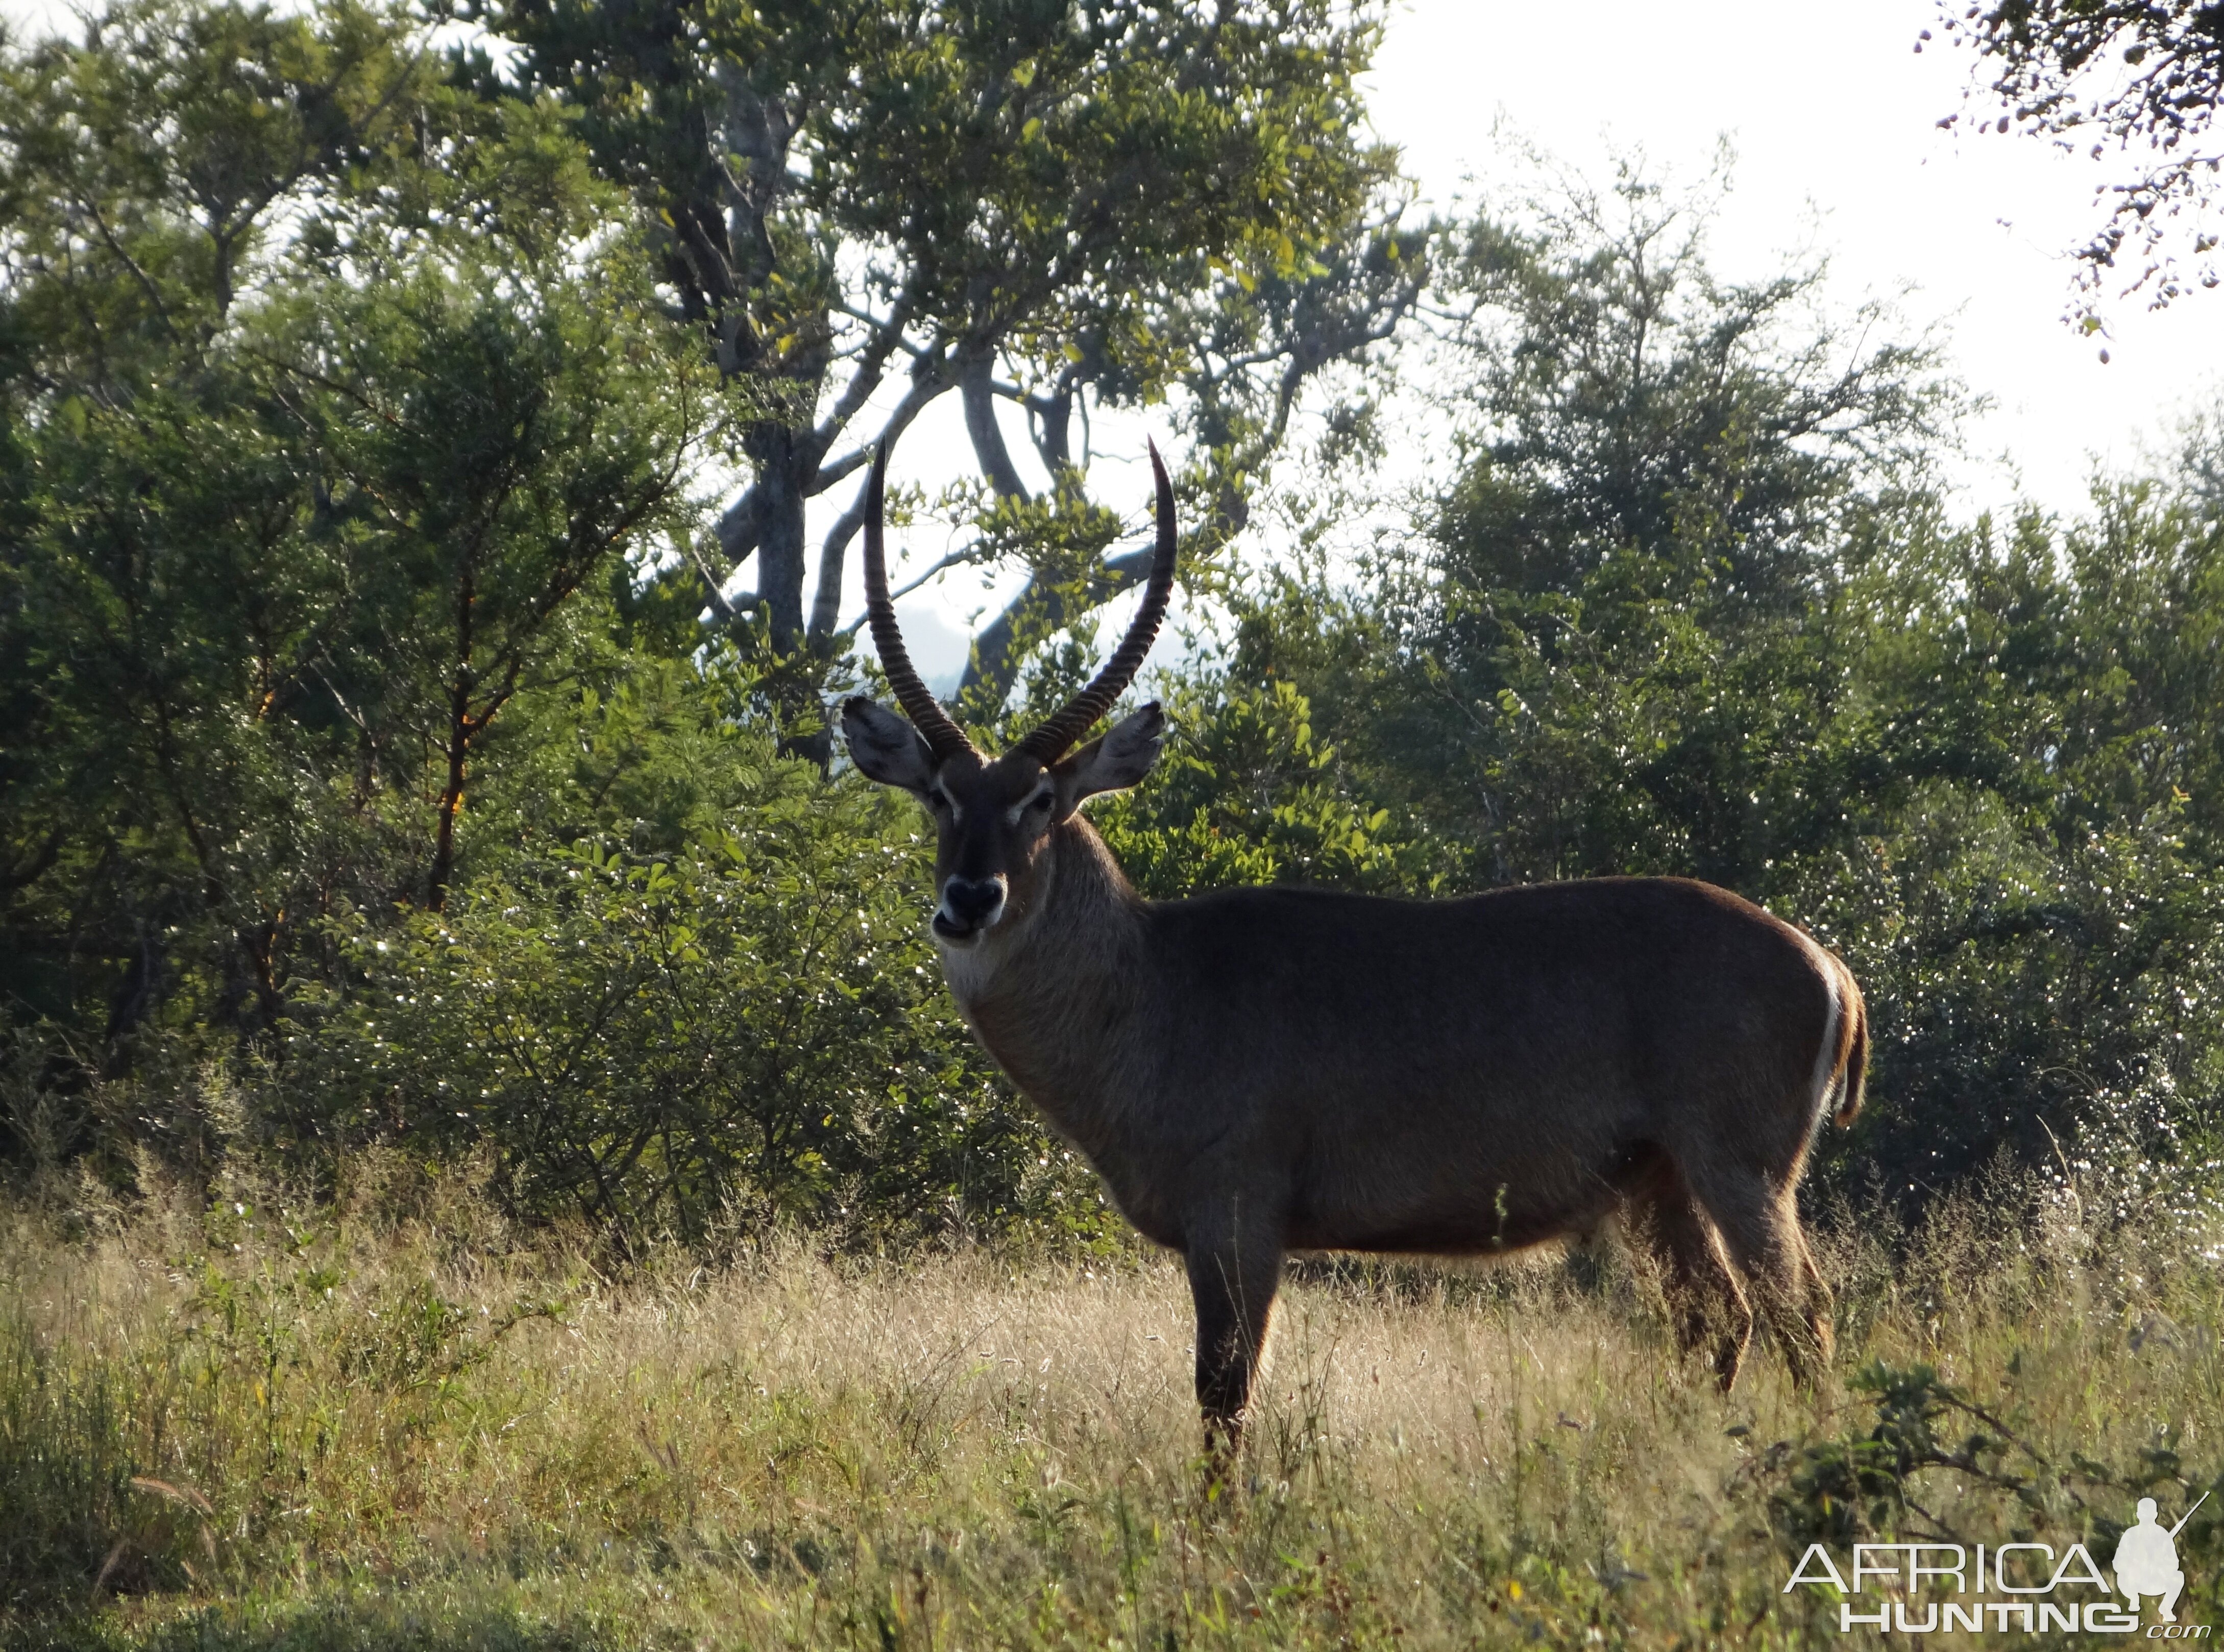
[1290,171,1955,885]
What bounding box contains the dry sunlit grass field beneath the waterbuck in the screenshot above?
[0,1178,2224,1652]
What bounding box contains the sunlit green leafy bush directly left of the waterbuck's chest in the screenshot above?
[285,667,1063,1245]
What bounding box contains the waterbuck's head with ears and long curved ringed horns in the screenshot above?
[841,445,1174,947]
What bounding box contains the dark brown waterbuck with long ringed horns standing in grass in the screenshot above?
[843,449,1868,1445]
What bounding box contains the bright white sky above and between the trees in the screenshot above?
[0,0,2224,678]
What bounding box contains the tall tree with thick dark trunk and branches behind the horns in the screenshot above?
[472,0,1421,754]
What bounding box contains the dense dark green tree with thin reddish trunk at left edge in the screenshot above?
[0,0,703,1067]
